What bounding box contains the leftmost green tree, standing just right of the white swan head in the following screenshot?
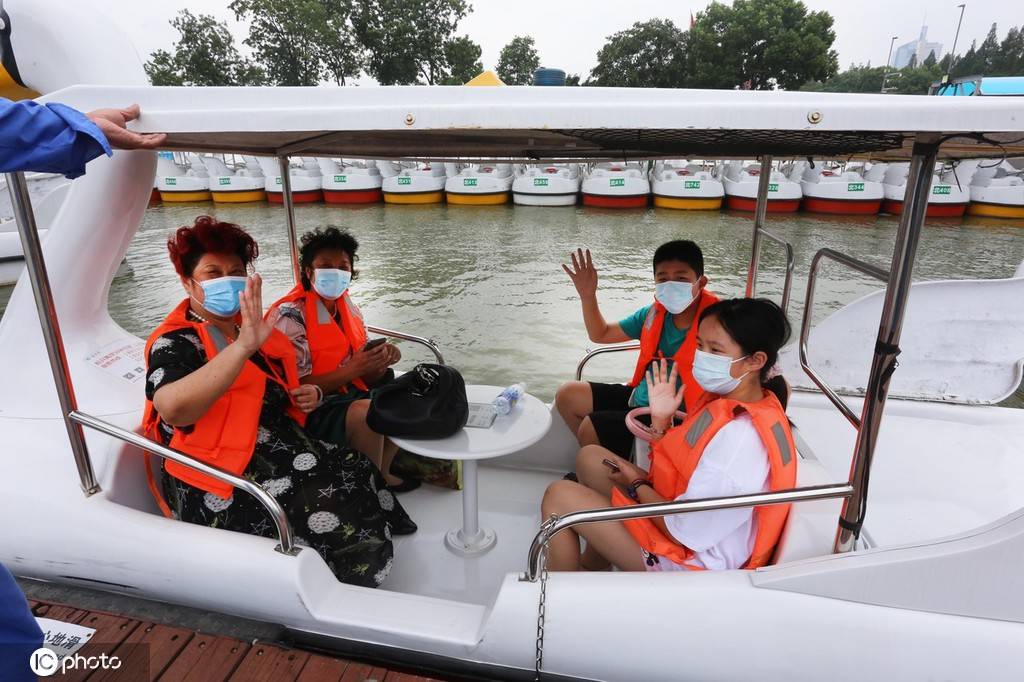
[143,9,266,85]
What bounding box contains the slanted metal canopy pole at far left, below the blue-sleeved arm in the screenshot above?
[7,173,100,497]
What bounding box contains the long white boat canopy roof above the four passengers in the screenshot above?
[42,85,1024,161]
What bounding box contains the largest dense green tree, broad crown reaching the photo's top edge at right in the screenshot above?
[687,0,839,90]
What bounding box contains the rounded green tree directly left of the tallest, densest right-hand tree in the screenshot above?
[587,18,686,88]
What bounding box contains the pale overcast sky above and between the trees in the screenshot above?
[103,0,1024,81]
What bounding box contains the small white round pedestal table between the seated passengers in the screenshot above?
[391,385,551,556]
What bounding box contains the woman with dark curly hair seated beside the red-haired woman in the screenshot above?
[272,227,420,493]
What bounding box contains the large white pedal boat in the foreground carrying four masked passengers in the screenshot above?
[6,0,1024,681]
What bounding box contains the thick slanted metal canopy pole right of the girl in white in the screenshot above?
[834,133,940,552]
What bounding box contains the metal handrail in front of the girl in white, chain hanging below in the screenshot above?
[521,483,853,583]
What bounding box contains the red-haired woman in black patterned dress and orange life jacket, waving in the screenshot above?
[143,216,411,587]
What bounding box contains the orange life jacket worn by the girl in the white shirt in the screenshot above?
[611,390,797,570]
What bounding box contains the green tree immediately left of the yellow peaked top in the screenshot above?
[352,0,479,85]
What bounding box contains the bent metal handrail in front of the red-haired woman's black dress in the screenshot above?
[68,410,302,556]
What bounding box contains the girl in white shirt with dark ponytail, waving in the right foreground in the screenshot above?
[541,299,796,570]
